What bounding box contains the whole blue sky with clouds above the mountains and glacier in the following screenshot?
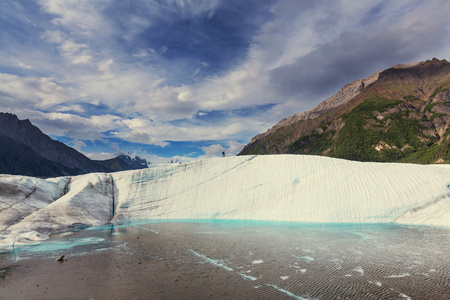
[0,0,450,163]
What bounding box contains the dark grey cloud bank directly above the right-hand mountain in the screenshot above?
[271,2,450,102]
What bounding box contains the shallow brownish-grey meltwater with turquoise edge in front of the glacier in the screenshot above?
[0,223,450,299]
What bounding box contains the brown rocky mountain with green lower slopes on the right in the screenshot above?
[239,59,450,163]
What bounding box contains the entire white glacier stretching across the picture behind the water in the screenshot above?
[0,155,450,247]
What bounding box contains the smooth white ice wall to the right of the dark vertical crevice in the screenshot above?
[112,155,450,225]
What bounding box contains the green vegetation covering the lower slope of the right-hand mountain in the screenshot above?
[288,95,444,163]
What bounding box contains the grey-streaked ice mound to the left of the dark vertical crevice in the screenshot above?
[0,173,113,246]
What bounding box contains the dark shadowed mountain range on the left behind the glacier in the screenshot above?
[0,113,148,177]
